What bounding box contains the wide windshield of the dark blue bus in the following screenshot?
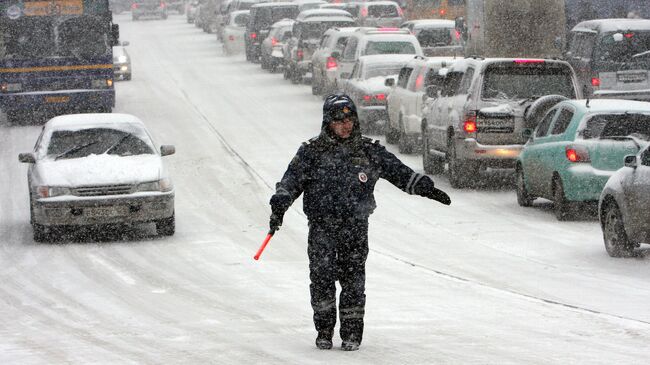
[0,16,111,60]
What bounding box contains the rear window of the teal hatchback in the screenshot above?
[580,113,650,141]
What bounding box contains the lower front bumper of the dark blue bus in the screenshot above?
[0,89,115,112]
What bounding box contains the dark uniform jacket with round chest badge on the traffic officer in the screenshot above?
[276,133,423,220]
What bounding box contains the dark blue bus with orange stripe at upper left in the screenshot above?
[0,0,119,124]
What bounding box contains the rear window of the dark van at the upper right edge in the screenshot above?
[594,31,650,63]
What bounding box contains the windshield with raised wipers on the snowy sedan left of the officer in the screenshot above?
[47,128,154,159]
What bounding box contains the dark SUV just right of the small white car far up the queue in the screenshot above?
[244,2,298,61]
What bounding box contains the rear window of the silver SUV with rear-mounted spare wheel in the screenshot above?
[481,66,575,100]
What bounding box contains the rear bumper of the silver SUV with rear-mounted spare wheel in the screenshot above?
[456,138,524,168]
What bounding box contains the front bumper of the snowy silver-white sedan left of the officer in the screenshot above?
[32,192,174,226]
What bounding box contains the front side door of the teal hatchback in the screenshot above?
[519,108,559,197]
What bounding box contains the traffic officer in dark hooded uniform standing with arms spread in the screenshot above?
[270,94,451,351]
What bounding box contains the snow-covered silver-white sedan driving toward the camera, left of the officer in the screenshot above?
[18,114,175,241]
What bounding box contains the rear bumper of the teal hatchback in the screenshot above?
[560,163,615,201]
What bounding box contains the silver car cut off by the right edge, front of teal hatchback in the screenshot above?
[598,142,650,257]
